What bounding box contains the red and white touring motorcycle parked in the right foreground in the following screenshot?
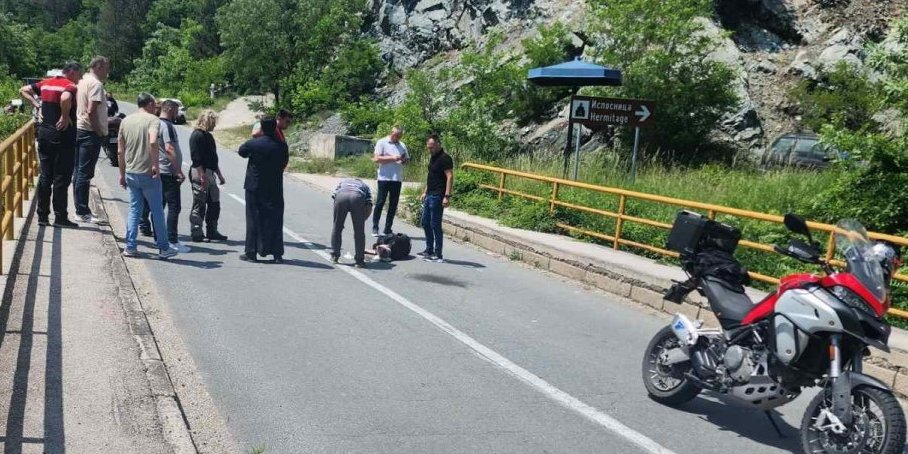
[642,212,906,454]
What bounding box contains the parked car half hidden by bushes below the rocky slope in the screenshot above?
[762,133,846,169]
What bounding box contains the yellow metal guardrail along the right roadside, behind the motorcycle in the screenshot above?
[461,162,908,319]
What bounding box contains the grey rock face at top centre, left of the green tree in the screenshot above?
[372,0,535,70]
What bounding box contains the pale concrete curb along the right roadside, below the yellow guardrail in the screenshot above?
[290,174,908,400]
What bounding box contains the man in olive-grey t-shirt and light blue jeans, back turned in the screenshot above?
[117,93,179,259]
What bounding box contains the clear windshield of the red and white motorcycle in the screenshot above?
[835,219,886,302]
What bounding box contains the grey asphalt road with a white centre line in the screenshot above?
[98,104,809,453]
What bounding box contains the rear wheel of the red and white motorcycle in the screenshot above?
[642,326,701,406]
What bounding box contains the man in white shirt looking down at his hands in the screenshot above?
[372,125,410,237]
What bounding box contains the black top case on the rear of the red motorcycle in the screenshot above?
[666,211,741,254]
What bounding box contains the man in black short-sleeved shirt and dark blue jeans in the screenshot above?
[416,134,454,263]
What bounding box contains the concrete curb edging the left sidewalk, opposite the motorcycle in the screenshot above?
[91,187,199,454]
